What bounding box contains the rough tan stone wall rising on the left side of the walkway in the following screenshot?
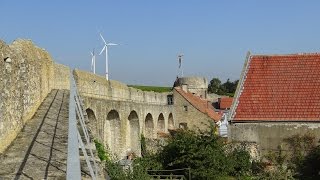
[0,39,68,153]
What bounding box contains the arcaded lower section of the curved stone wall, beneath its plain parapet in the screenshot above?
[82,96,173,158]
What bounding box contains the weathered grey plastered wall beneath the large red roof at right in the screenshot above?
[228,122,320,155]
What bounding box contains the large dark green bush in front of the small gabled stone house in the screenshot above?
[159,130,251,179]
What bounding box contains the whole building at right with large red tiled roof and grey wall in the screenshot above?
[228,54,320,154]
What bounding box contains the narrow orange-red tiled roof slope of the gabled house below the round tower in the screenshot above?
[174,87,221,122]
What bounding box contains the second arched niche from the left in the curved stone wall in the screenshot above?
[105,110,121,155]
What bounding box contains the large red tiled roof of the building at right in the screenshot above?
[233,54,320,121]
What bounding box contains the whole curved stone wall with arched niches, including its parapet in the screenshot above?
[74,70,175,159]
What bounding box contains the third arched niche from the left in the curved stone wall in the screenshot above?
[128,111,141,155]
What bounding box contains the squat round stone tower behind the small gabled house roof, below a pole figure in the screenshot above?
[174,77,208,99]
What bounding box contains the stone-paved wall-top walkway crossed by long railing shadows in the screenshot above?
[0,90,69,180]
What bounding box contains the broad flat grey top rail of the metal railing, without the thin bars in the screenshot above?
[67,73,81,180]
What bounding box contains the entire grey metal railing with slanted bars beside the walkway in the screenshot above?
[67,72,98,180]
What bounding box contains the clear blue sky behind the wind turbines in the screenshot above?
[0,0,320,86]
